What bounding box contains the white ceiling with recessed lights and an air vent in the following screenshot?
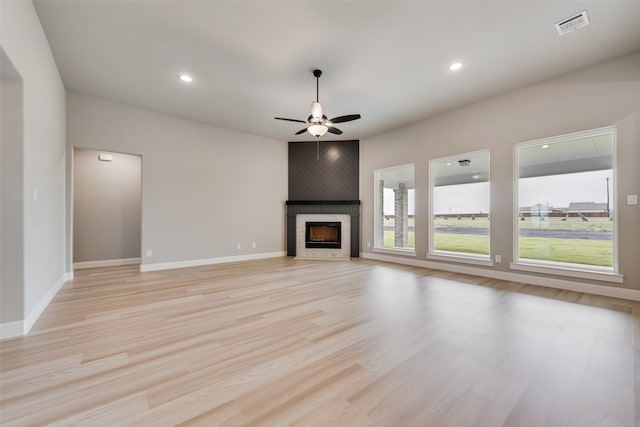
[34,0,640,141]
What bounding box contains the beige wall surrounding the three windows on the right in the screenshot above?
[360,52,640,289]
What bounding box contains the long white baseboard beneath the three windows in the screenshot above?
[360,252,640,301]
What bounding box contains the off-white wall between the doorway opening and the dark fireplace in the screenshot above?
[67,93,287,270]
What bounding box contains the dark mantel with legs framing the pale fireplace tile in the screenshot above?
[286,200,360,257]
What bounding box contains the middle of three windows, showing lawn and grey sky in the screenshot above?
[428,151,490,262]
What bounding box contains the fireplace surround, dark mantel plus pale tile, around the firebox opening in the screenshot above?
[287,200,360,259]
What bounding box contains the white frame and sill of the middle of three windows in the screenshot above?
[427,148,493,267]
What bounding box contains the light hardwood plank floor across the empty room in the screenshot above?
[0,258,640,427]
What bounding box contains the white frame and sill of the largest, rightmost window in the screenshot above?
[509,125,623,283]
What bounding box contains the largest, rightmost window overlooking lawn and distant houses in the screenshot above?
[514,128,616,272]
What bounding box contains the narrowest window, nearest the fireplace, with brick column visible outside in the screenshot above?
[374,164,415,254]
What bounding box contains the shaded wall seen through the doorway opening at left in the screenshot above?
[73,149,142,267]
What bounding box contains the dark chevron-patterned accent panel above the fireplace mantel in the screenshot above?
[289,140,360,201]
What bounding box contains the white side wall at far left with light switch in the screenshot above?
[0,1,66,336]
